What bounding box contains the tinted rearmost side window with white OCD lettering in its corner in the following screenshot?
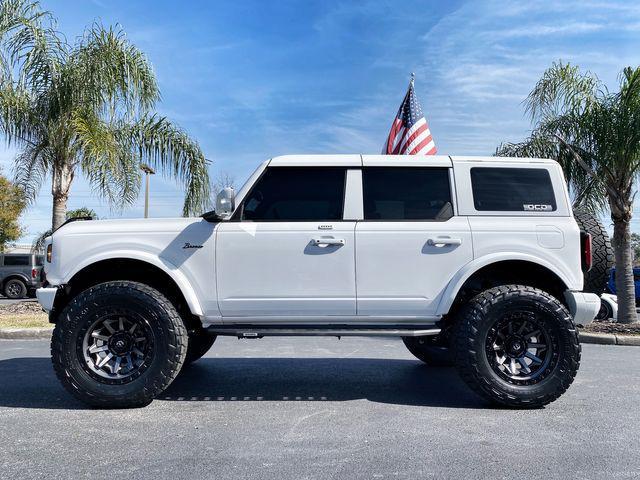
[471,167,556,212]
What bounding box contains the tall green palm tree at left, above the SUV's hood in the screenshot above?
[0,0,209,230]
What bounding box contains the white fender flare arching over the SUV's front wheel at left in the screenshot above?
[64,250,204,317]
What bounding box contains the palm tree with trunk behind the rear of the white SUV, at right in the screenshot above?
[497,63,640,323]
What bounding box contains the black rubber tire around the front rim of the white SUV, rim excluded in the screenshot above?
[51,281,187,408]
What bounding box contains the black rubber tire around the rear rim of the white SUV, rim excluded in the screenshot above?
[453,285,581,408]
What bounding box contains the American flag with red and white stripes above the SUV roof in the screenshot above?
[382,76,438,155]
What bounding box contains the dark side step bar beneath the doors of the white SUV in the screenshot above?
[207,326,440,338]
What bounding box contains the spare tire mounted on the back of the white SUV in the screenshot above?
[573,210,613,296]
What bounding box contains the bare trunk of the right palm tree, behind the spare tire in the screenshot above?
[611,219,638,323]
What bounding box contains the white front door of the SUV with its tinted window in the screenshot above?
[216,167,356,323]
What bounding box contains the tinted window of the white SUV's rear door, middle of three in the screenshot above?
[362,167,453,220]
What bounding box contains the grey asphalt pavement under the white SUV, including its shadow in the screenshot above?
[0,338,640,480]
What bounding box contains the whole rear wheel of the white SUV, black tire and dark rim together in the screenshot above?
[454,285,580,408]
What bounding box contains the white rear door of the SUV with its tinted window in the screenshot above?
[356,157,473,317]
